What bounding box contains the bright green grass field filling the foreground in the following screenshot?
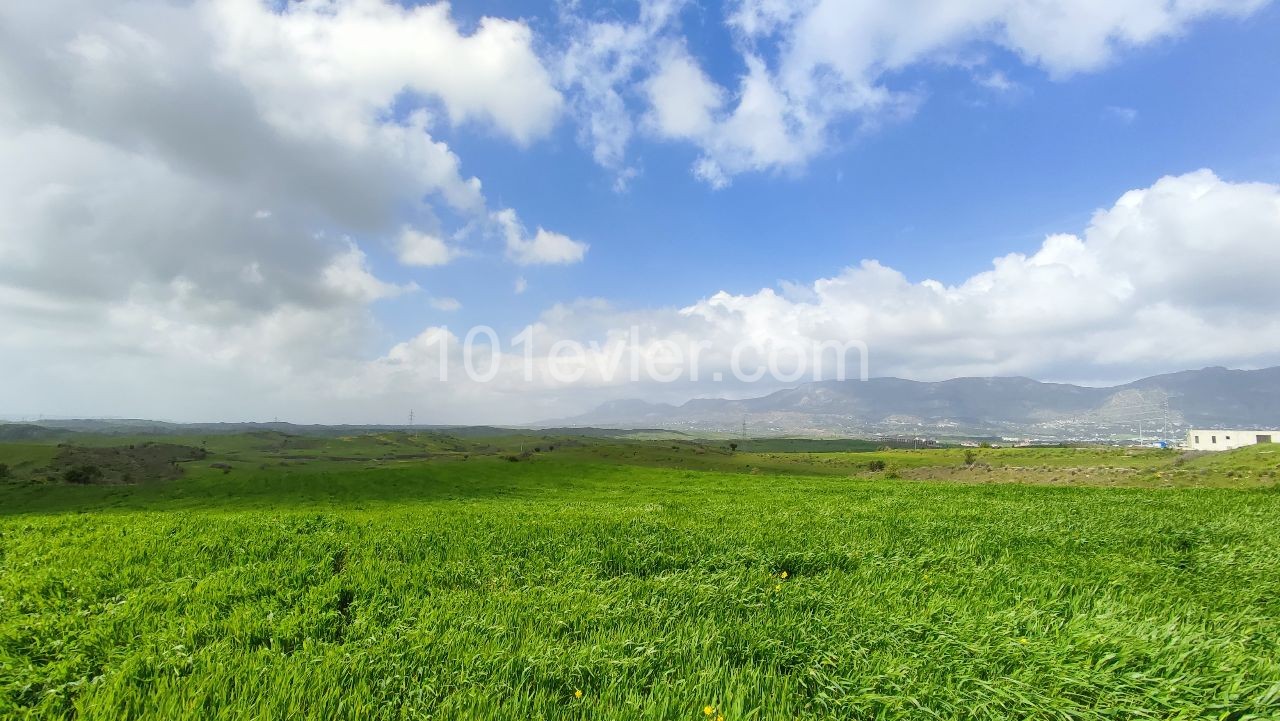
[0,434,1280,720]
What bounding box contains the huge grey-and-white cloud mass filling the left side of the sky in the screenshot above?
[0,0,573,417]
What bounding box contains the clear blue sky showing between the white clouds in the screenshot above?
[366,3,1280,343]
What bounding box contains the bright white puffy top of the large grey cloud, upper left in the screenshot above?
[205,0,561,143]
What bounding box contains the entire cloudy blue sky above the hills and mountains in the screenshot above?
[0,0,1280,424]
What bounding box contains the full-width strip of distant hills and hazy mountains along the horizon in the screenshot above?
[0,368,1280,441]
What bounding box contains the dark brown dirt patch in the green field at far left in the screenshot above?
[46,443,207,483]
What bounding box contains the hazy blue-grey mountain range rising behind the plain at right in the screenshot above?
[554,368,1280,439]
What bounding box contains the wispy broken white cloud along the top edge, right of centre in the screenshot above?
[567,0,1268,187]
